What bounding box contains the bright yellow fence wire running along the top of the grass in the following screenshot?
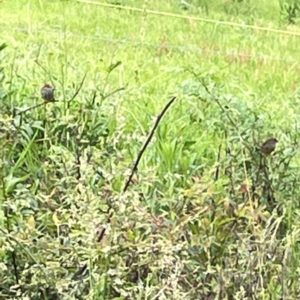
[76,0,300,36]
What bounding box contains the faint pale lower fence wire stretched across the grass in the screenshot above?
[0,25,298,63]
